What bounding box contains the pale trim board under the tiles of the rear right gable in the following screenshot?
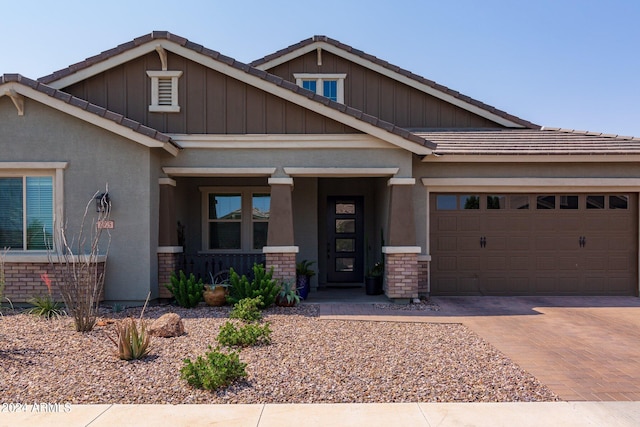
[256,41,524,128]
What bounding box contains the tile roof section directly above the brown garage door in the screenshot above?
[413,128,640,155]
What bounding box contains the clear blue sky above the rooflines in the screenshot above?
[0,0,640,137]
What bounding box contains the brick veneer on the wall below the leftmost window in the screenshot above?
[3,260,104,303]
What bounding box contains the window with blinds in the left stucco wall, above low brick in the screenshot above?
[0,176,53,250]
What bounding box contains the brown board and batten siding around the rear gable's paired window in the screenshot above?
[267,50,502,128]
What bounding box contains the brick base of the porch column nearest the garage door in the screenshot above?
[384,253,418,300]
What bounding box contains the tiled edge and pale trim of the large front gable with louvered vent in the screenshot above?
[39,31,435,155]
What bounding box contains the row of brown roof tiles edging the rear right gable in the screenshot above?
[250,36,540,129]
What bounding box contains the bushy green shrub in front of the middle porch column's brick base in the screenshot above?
[227,264,280,309]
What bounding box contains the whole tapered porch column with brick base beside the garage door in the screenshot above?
[382,178,421,302]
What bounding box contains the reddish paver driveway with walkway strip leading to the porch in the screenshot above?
[320,297,640,401]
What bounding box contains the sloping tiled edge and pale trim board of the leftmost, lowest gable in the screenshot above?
[0,74,178,155]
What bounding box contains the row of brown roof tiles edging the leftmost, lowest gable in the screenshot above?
[0,74,179,148]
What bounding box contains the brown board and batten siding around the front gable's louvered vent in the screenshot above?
[63,52,360,134]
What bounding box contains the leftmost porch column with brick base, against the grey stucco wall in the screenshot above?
[158,178,183,298]
